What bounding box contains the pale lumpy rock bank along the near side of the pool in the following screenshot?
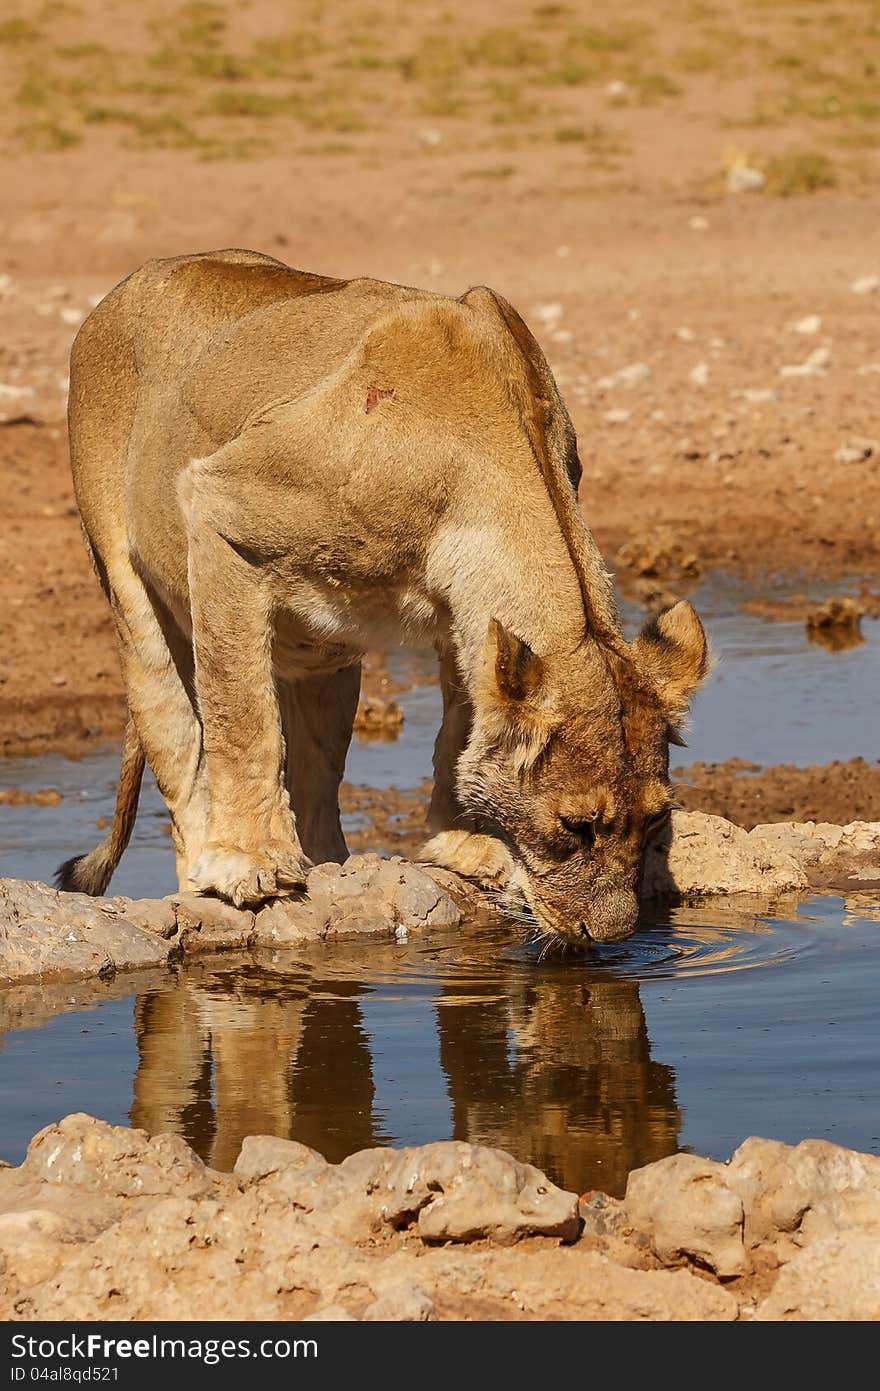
[0,1114,880,1321]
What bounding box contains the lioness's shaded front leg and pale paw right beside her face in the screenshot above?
[417,648,513,889]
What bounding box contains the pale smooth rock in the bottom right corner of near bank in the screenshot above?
[755,1231,880,1323]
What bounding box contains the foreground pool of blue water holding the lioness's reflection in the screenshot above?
[0,896,880,1195]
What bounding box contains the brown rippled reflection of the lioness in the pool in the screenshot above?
[131,944,681,1193]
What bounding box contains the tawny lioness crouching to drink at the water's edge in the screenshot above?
[58,250,706,942]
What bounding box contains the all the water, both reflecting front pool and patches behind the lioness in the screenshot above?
[0,580,880,1193]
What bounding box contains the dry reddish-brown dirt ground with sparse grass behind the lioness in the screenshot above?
[0,0,880,825]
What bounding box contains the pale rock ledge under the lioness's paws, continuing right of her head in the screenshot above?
[0,812,880,986]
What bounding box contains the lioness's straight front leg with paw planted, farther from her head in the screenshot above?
[186,487,310,907]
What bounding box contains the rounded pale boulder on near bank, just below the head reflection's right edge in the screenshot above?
[624,1155,751,1277]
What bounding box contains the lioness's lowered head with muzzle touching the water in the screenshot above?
[457,601,708,943]
